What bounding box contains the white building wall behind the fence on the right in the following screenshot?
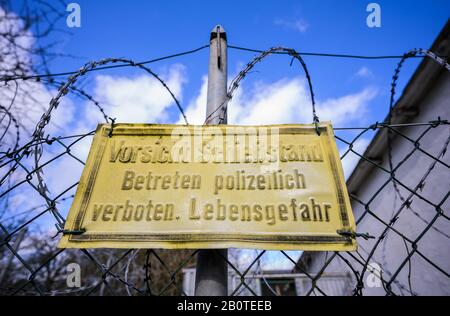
[309,72,450,295]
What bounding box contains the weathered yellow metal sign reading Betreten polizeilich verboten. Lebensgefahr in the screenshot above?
[59,123,356,250]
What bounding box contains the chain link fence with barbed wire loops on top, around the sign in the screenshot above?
[0,41,450,295]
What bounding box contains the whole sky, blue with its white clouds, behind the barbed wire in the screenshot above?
[5,0,450,270]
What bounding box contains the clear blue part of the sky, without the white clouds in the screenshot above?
[29,0,450,133]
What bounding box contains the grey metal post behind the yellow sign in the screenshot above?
[195,25,228,296]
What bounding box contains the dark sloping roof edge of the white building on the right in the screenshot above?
[347,20,450,194]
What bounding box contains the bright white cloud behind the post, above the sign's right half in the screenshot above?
[179,78,377,126]
